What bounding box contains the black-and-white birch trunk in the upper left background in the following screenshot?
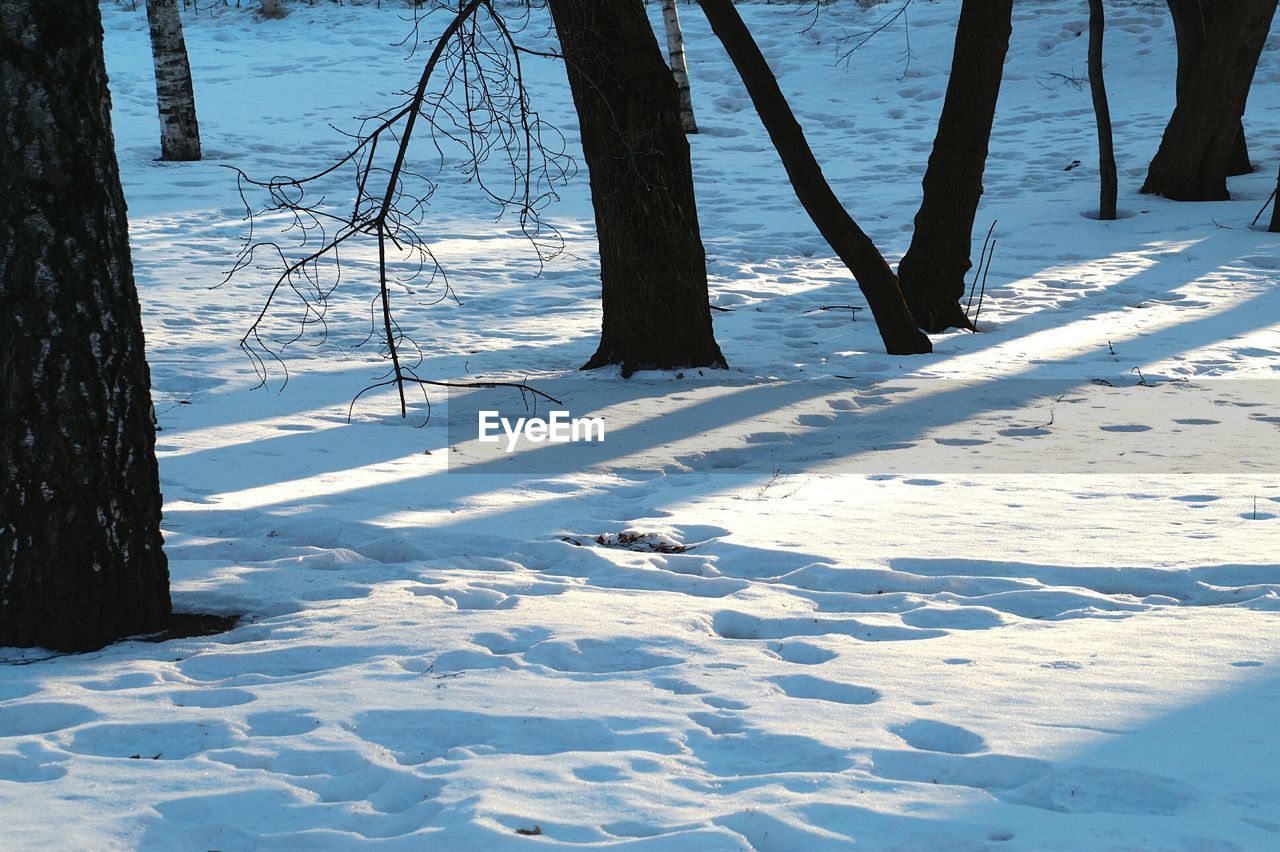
[147,0,200,160]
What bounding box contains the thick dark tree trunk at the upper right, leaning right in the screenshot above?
[1142,0,1276,201]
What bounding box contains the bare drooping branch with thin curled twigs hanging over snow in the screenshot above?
[224,0,575,417]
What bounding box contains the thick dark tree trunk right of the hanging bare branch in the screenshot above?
[549,0,726,376]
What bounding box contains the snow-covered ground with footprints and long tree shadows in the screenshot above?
[0,0,1280,851]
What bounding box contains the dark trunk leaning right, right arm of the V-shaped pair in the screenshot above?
[897,0,1014,331]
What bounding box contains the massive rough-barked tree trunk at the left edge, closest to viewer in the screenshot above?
[0,0,169,651]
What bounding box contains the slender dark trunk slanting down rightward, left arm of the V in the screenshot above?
[699,0,932,354]
